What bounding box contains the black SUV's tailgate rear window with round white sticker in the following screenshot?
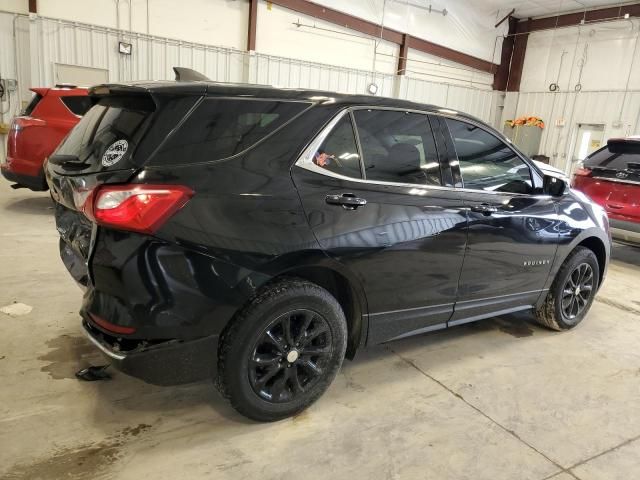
[52,96,155,168]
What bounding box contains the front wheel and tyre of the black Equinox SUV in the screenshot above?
[535,247,600,331]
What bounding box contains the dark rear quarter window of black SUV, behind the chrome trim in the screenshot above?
[153,98,310,165]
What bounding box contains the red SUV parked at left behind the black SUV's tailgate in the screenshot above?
[0,85,92,190]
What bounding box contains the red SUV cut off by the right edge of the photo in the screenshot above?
[573,137,640,244]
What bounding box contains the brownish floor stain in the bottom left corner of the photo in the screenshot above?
[4,424,151,480]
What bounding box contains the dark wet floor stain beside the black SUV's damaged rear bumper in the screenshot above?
[38,335,101,380]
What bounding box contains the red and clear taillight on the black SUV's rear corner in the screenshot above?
[82,185,193,234]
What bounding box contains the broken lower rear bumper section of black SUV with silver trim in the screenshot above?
[82,319,218,385]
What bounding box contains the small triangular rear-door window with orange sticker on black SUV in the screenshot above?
[313,115,362,178]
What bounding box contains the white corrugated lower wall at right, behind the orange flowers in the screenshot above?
[502,91,640,171]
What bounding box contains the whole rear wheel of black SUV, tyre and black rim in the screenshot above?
[216,278,347,422]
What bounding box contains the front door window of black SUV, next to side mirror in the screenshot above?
[447,119,532,193]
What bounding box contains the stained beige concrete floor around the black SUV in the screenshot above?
[0,182,640,480]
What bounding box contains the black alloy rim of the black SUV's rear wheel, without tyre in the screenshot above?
[249,309,333,403]
